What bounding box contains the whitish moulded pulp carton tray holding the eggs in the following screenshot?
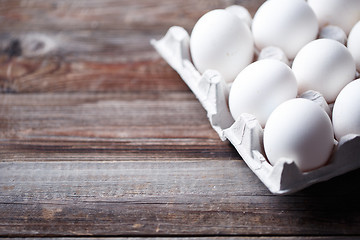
[151,26,360,195]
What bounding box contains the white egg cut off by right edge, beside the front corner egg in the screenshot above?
[332,79,360,140]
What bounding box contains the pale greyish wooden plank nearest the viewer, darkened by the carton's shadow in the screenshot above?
[0,160,360,236]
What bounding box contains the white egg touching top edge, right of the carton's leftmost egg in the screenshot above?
[252,0,318,59]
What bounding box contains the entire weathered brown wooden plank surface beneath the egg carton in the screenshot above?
[0,0,360,239]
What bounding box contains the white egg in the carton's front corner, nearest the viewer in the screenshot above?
[264,98,334,172]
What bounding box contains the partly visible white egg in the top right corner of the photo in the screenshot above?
[308,0,360,34]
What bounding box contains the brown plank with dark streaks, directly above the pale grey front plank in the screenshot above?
[0,92,240,161]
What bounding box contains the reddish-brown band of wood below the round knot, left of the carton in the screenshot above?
[0,56,188,93]
